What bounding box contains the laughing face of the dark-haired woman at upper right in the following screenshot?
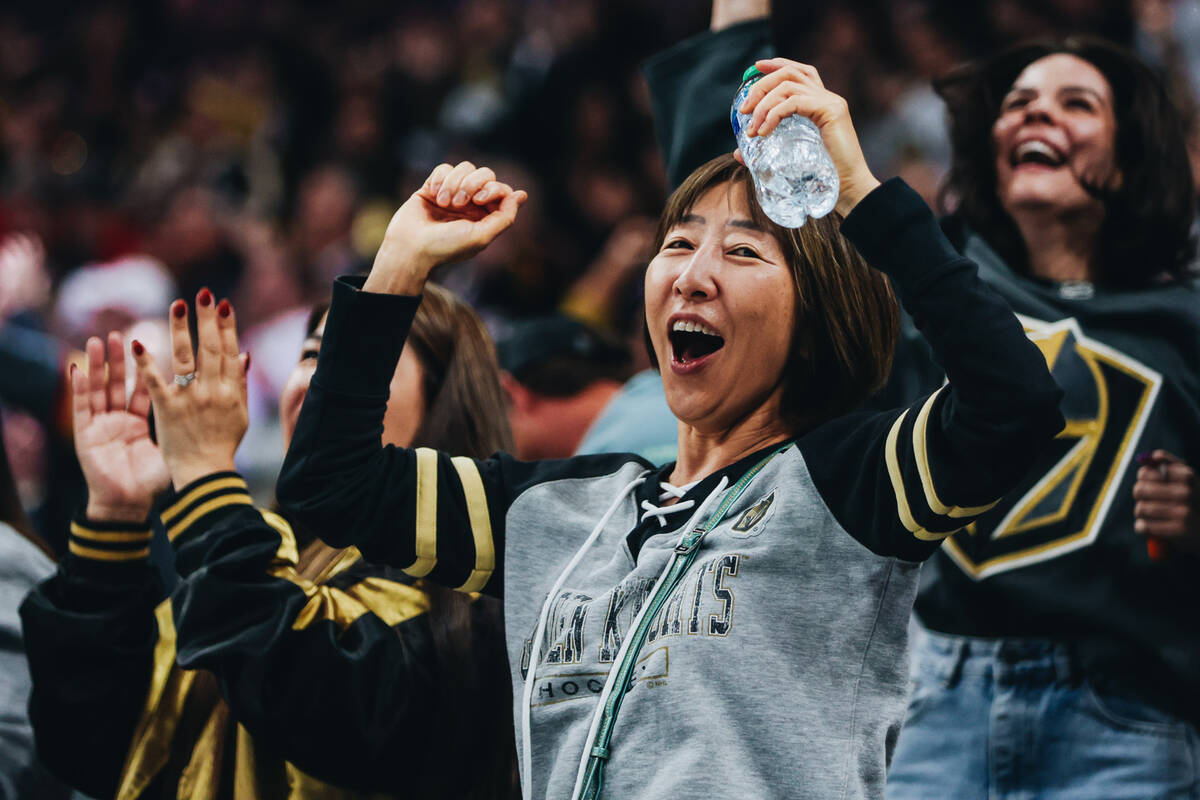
[991,53,1121,218]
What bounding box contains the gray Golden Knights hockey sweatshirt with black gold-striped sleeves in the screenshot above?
[278,181,1062,800]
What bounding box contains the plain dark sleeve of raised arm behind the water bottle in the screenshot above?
[642,19,775,190]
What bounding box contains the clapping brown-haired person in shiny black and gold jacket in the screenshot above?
[22,289,516,800]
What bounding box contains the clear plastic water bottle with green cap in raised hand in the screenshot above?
[730,67,840,228]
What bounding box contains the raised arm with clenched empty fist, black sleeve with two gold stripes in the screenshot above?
[276,164,524,594]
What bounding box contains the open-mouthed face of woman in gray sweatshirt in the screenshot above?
[646,182,796,432]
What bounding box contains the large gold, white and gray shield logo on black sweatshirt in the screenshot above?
[942,317,1162,581]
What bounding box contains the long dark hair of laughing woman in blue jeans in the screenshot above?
[934,36,1195,289]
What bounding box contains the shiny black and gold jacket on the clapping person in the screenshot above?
[20,473,512,800]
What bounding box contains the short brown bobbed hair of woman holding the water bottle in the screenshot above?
[646,155,900,433]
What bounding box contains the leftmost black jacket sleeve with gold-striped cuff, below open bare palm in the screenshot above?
[20,519,164,798]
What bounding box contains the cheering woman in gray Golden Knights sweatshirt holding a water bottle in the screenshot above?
[278,67,1062,799]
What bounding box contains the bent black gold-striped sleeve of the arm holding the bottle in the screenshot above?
[799,179,1063,560]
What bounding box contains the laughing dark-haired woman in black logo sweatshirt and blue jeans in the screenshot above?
[646,2,1200,799]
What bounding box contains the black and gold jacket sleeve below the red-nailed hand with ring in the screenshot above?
[163,473,511,792]
